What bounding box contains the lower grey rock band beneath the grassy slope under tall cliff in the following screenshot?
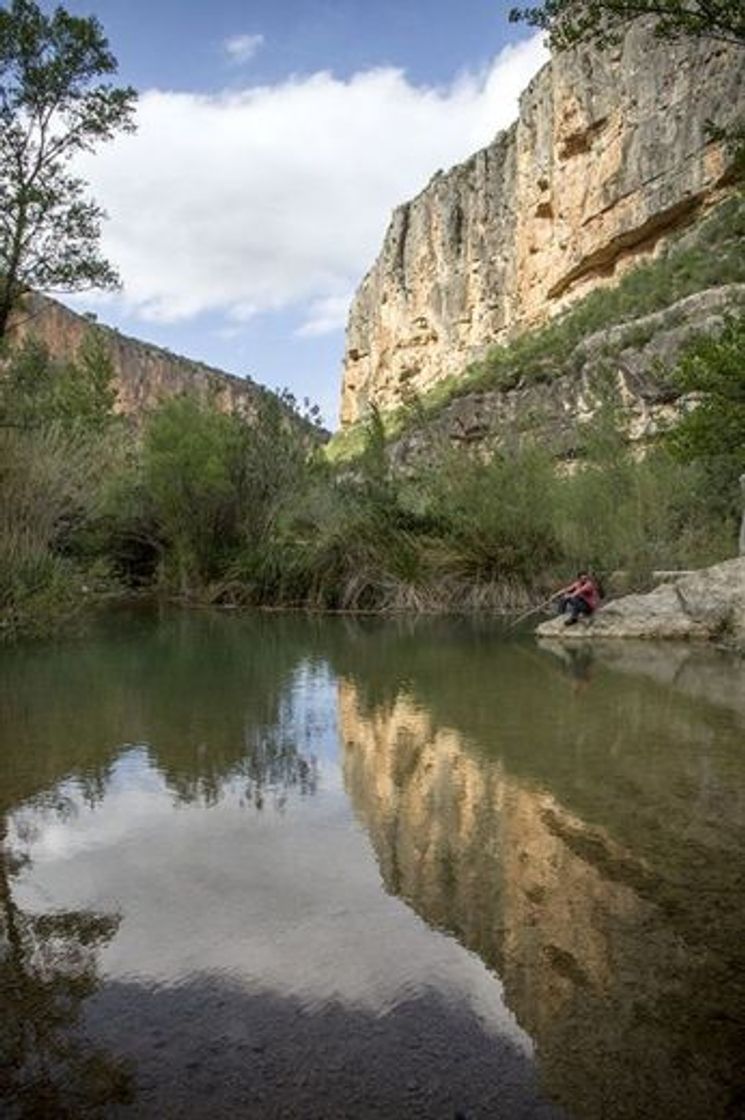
[389,283,745,469]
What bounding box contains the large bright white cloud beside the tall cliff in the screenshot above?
[82,37,546,336]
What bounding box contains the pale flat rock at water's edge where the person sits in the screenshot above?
[536,557,745,653]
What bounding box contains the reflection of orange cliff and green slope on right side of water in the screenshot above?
[339,645,745,1120]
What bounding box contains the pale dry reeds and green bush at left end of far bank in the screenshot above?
[0,337,123,636]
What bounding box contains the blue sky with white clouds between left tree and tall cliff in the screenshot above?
[44,0,547,428]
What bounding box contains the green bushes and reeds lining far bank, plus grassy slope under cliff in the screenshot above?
[0,207,745,637]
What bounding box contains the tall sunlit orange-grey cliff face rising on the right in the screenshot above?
[341,22,745,424]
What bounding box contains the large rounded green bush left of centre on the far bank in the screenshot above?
[133,395,311,594]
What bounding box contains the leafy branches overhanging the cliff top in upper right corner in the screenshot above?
[510,0,745,50]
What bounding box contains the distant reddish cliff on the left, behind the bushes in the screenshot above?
[7,296,268,420]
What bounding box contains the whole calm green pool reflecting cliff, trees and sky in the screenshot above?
[0,613,745,1120]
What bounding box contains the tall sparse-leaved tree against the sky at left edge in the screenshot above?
[0,0,137,339]
